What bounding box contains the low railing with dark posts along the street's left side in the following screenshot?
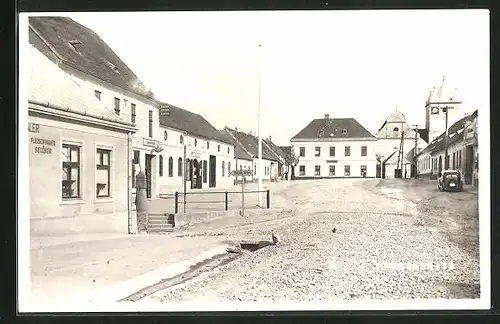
[174,190,271,214]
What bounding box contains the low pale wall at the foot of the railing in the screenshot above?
[174,208,283,227]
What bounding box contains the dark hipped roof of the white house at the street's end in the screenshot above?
[292,118,375,140]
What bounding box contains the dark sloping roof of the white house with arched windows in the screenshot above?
[160,103,234,145]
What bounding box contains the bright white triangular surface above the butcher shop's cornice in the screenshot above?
[28,46,133,127]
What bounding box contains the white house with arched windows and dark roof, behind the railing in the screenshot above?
[158,104,236,193]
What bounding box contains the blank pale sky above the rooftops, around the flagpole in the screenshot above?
[57,10,489,145]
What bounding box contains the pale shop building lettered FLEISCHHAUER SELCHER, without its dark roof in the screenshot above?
[29,41,137,237]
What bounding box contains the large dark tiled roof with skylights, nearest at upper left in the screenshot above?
[29,17,154,99]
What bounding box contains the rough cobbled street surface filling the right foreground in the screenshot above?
[148,179,479,302]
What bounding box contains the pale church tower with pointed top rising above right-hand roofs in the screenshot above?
[425,77,463,143]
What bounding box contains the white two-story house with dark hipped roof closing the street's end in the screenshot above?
[290,114,377,179]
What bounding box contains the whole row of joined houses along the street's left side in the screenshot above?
[28,17,288,236]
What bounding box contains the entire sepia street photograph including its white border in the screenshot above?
[17,10,491,313]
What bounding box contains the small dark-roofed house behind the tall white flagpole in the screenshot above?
[224,127,280,181]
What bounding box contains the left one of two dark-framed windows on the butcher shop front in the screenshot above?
[61,144,81,199]
